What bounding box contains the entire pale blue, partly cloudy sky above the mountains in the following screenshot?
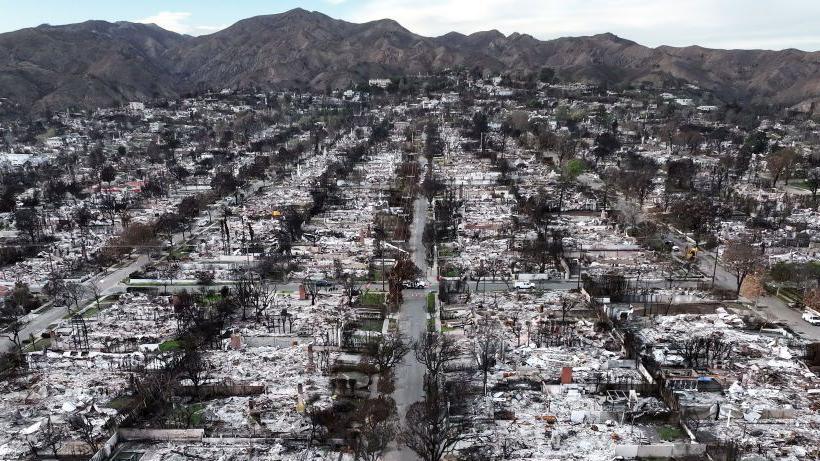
[0,0,820,51]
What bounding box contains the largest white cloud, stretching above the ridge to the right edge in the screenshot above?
[346,0,820,50]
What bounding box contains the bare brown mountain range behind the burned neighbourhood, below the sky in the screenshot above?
[0,9,820,112]
